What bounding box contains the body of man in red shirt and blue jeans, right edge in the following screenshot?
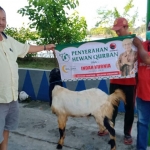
[133,37,150,150]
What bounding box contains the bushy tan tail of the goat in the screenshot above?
[110,89,126,106]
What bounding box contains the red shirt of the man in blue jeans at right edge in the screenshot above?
[137,41,150,101]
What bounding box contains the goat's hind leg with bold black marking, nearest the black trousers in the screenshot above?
[104,117,116,150]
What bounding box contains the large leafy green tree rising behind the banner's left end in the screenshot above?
[18,0,87,44]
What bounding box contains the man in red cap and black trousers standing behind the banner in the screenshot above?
[98,17,136,145]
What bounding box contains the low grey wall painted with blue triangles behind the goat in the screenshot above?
[19,68,136,112]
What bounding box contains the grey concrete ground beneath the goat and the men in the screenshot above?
[8,101,150,150]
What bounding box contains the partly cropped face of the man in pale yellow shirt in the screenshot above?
[0,10,6,32]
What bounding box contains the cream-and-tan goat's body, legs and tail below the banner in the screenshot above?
[51,85,125,150]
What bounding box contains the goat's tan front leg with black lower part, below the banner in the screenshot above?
[57,115,67,149]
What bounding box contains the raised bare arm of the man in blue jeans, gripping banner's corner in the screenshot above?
[133,37,150,65]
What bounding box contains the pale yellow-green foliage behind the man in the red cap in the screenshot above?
[90,0,138,37]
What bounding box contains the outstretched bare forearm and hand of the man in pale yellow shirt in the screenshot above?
[28,44,55,53]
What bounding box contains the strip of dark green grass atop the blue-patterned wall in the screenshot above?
[17,57,57,70]
